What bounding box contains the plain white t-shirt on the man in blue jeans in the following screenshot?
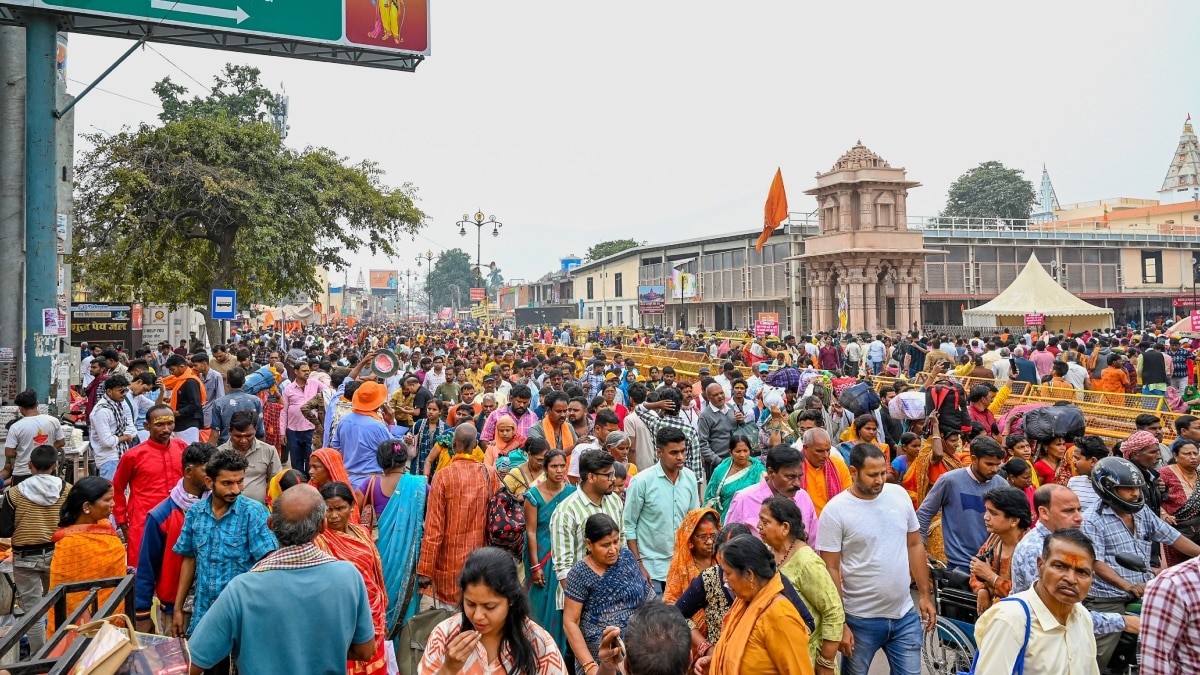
[816,483,919,619]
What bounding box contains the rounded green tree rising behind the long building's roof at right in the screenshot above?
[942,162,1038,220]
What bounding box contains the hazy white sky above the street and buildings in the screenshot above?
[68,0,1200,280]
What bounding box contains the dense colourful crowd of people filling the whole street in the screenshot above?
[0,324,1200,675]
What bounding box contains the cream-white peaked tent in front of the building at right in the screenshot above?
[962,255,1112,330]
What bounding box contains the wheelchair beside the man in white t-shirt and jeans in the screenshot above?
[920,560,979,675]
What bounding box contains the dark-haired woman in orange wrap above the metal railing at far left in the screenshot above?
[47,476,126,634]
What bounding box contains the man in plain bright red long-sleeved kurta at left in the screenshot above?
[113,405,187,567]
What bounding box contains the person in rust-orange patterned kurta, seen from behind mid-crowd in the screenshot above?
[416,422,500,608]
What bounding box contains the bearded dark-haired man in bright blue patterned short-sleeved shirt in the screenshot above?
[172,450,278,637]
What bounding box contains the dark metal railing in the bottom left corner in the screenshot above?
[0,574,134,675]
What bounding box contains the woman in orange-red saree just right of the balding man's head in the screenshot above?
[313,480,391,675]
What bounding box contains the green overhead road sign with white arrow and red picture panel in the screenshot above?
[0,0,430,70]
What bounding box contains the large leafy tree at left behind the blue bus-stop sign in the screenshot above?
[72,67,425,344]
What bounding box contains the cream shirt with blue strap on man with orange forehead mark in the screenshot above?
[976,589,1099,675]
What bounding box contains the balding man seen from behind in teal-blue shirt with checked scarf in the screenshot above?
[187,485,376,675]
